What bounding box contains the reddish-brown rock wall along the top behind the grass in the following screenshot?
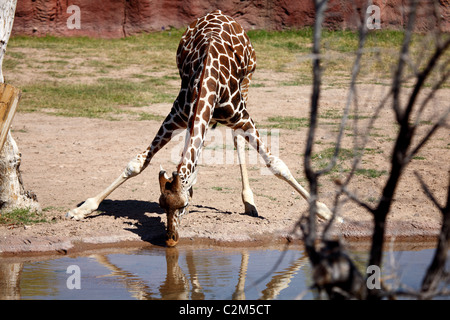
[13,0,450,38]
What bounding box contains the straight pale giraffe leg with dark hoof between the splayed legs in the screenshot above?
[233,131,258,217]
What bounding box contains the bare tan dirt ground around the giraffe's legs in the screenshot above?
[0,82,450,253]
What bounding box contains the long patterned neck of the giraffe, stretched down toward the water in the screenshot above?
[177,41,218,192]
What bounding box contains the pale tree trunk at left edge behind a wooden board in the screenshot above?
[0,0,41,211]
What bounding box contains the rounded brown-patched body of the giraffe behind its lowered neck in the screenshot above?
[177,10,256,112]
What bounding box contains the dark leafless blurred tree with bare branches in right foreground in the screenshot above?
[297,0,450,299]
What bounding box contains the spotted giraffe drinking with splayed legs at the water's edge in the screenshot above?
[67,10,331,247]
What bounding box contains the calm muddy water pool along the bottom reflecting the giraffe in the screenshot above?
[0,247,442,299]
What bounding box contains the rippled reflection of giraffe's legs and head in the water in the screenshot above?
[91,248,308,300]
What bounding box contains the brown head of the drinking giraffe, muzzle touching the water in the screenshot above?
[159,170,189,247]
